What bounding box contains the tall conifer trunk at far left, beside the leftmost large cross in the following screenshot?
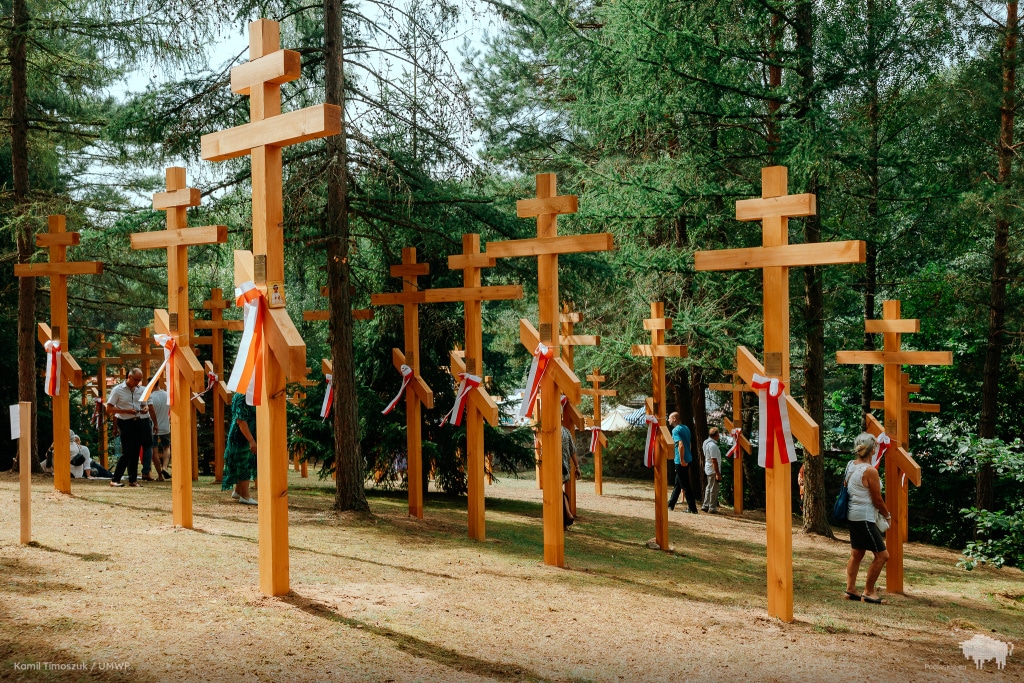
[8,0,41,472]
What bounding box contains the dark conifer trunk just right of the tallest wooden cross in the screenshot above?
[324,0,370,511]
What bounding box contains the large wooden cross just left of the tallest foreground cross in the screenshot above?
[131,166,227,528]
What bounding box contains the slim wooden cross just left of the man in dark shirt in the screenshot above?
[630,301,687,551]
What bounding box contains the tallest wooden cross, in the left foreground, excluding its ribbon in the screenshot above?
[201,19,341,596]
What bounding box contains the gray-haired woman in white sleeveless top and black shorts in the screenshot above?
[845,432,890,604]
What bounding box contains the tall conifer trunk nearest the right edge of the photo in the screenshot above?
[975,2,1019,510]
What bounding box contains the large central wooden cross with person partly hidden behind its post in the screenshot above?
[486,173,614,566]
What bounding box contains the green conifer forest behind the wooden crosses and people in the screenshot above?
[0,0,1024,567]
